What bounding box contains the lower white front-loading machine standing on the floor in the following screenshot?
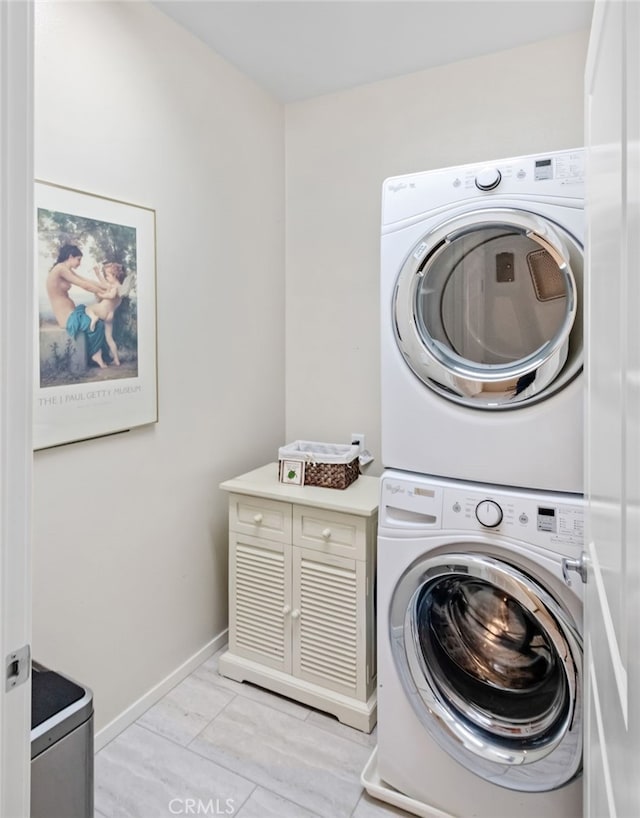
[363,470,584,818]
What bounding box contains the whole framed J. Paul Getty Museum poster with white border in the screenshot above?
[33,181,158,449]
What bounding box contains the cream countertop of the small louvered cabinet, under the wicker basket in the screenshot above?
[220,462,380,517]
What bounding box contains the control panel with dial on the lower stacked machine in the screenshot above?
[379,471,585,554]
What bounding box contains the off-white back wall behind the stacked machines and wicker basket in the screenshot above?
[286,31,588,474]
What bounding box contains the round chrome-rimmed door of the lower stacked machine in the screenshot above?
[389,553,582,792]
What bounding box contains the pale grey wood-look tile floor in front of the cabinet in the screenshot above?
[95,654,408,818]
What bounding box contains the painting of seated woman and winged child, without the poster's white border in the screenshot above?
[38,208,138,387]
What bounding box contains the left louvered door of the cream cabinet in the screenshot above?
[229,531,291,673]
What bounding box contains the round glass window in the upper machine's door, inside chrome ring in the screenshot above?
[416,225,568,365]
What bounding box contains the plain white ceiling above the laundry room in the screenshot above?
[154,0,593,103]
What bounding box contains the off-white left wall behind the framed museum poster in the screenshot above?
[33,2,284,729]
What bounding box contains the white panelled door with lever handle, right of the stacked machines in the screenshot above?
[585,0,640,818]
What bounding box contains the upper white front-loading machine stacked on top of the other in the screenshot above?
[381,149,584,493]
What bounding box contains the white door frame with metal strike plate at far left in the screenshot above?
[0,2,33,818]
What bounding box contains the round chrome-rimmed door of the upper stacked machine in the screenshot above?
[393,208,583,409]
